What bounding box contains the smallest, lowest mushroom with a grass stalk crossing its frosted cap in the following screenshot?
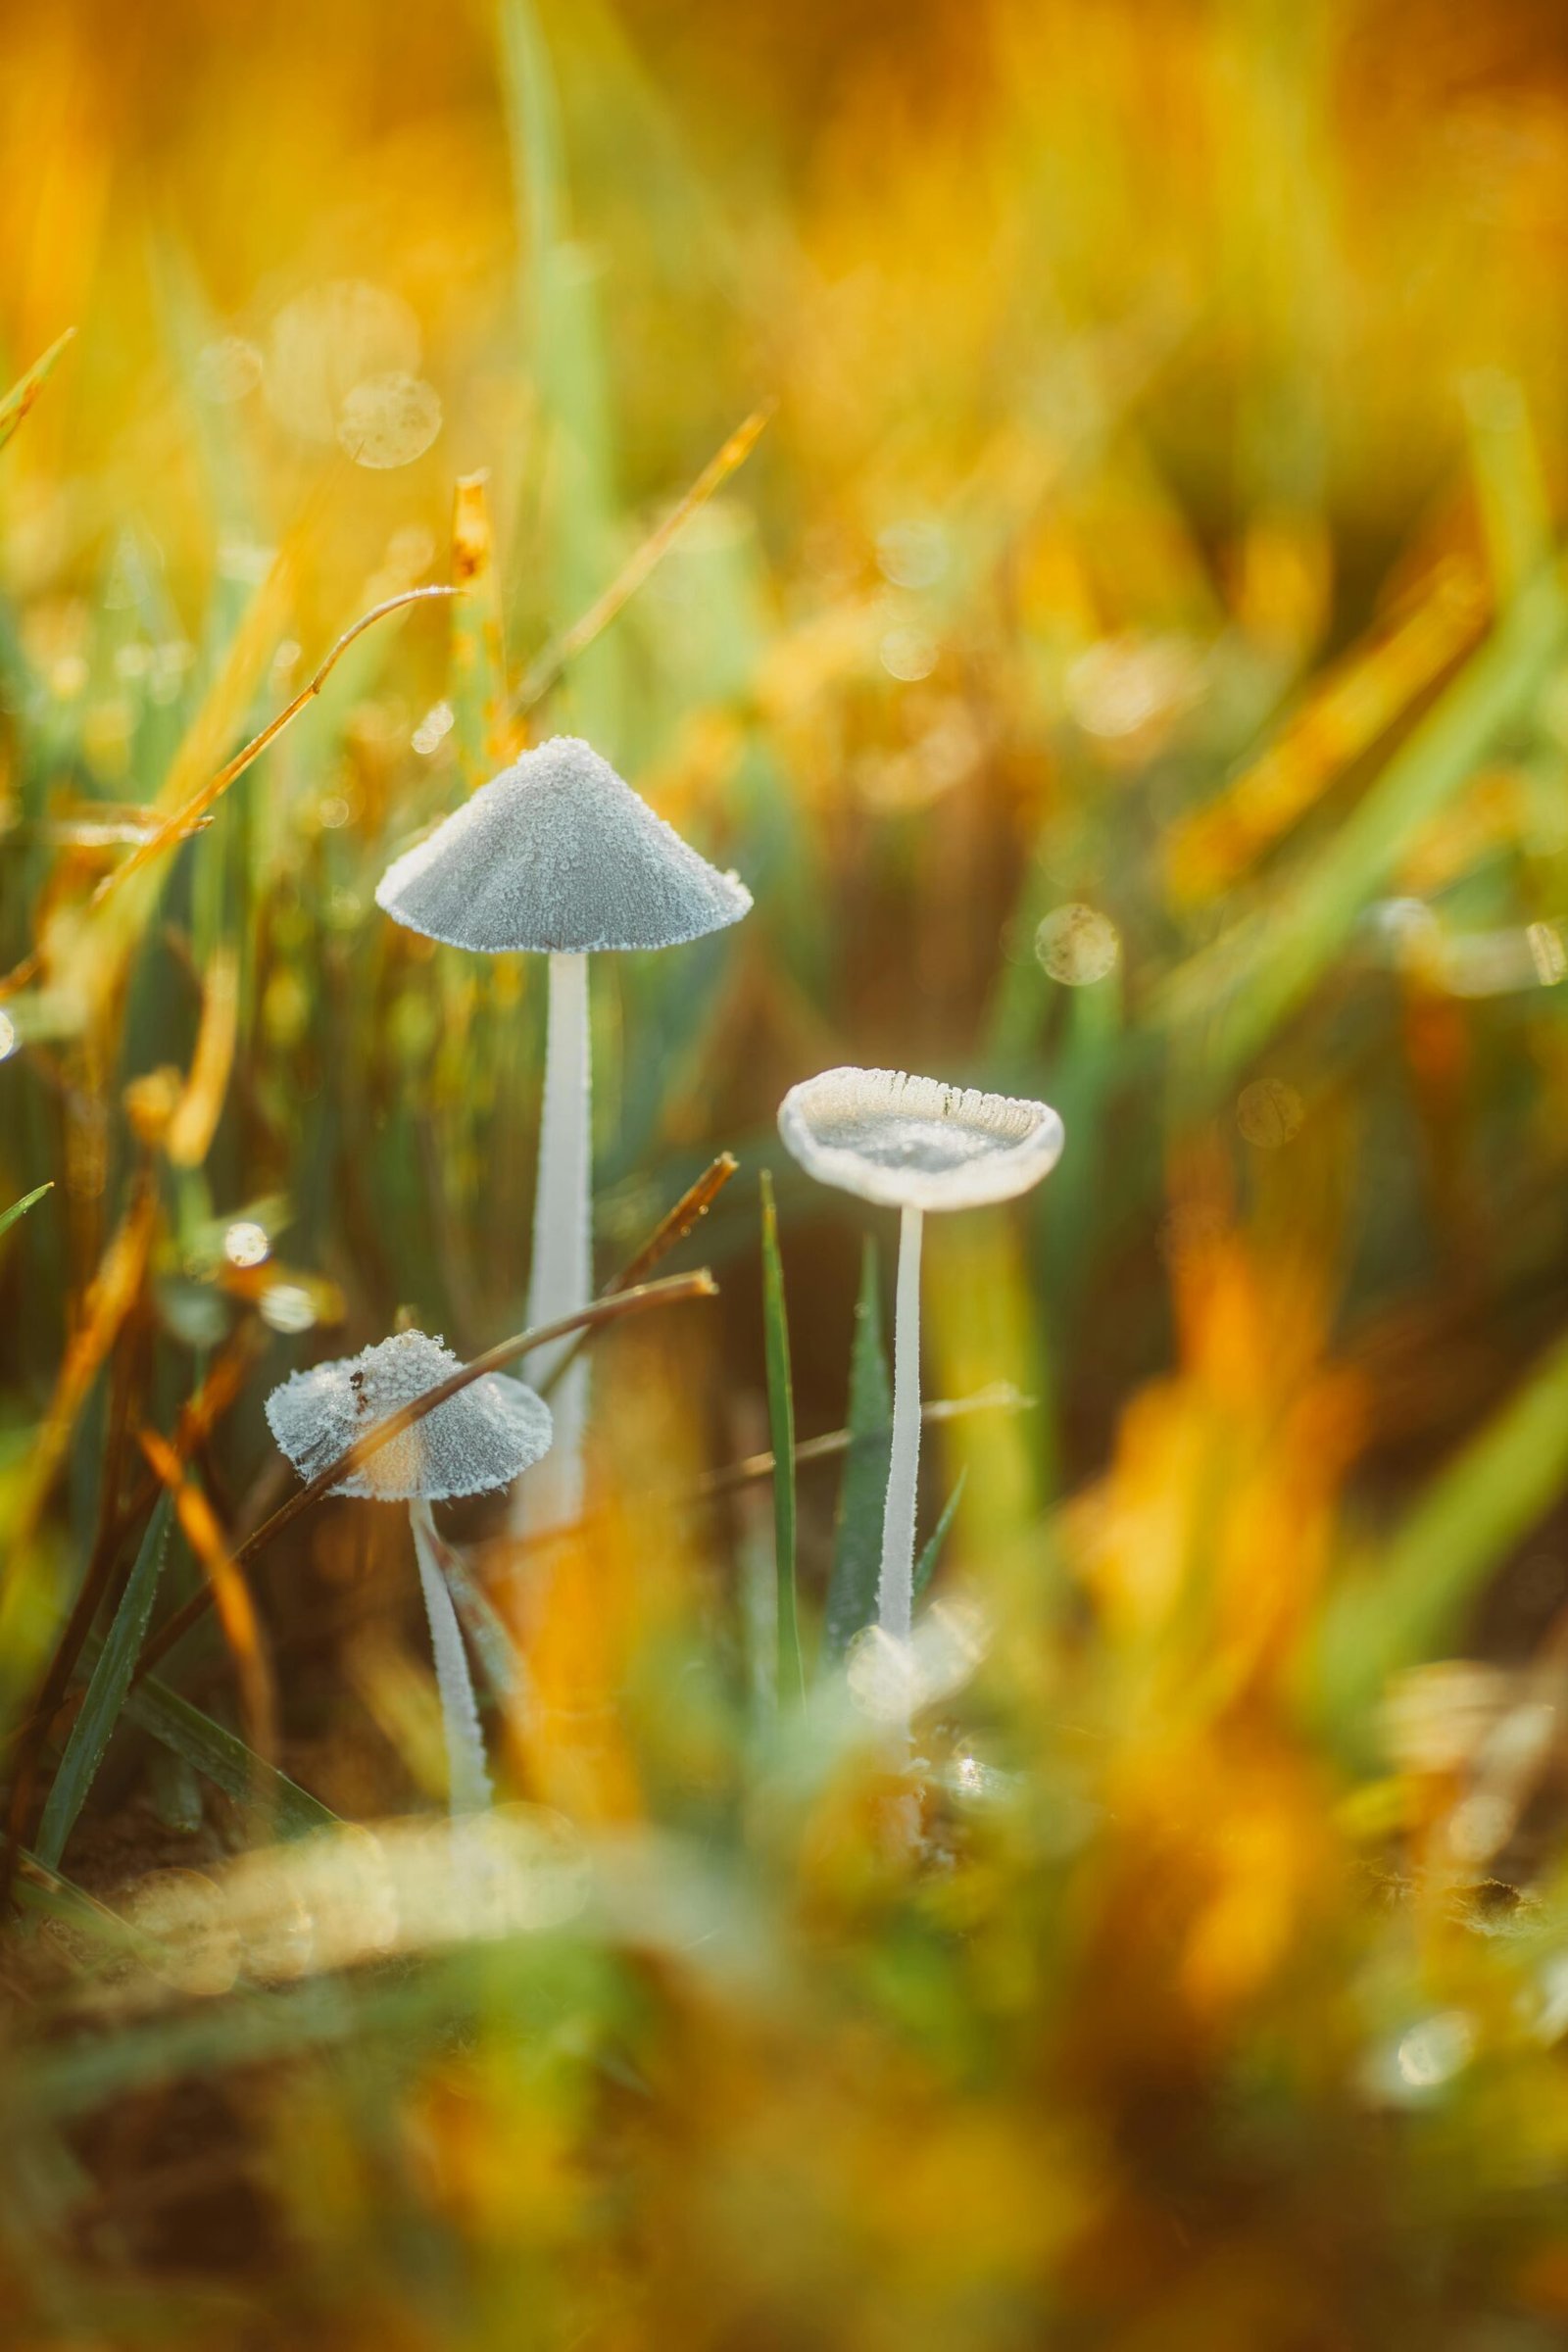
[266,1331,553,1813]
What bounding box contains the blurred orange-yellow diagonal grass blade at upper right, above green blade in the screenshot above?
[1168,564,1486,906]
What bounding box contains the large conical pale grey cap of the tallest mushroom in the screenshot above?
[376,736,753,955]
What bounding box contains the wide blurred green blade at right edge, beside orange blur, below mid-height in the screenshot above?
[1314,1339,1568,1747]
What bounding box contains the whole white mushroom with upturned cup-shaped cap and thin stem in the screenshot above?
[778,1068,1065,1642]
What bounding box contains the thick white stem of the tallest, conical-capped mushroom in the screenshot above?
[511,955,592,1531]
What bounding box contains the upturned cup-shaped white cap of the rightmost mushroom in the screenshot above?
[778,1068,1062,1209]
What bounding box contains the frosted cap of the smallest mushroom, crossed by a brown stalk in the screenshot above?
[266,1331,550,1503]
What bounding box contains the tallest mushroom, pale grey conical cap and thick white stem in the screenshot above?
[376,736,753,1524]
